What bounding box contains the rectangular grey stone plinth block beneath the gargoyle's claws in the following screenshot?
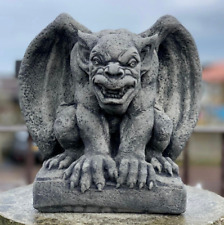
[33,168,186,214]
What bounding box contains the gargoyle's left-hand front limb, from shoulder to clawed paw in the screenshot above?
[64,104,117,192]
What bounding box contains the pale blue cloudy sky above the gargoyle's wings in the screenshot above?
[0,0,224,77]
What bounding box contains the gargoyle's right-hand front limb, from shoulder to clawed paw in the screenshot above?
[116,108,155,189]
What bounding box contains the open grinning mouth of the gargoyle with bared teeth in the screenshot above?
[97,84,134,99]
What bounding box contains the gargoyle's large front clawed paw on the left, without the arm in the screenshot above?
[64,155,117,193]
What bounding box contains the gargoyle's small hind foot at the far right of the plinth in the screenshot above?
[151,156,179,176]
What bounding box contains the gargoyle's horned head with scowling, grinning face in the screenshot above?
[79,30,157,114]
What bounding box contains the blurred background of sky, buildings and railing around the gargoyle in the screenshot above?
[0,0,224,195]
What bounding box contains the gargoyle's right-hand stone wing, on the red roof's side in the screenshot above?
[140,16,201,160]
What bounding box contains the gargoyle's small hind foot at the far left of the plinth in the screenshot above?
[44,151,76,170]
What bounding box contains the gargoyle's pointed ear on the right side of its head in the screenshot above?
[136,34,158,74]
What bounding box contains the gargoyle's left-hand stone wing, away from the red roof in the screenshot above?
[19,14,90,159]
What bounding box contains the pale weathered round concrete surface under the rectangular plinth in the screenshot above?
[0,185,224,225]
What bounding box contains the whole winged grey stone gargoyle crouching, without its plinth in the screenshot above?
[19,14,201,192]
